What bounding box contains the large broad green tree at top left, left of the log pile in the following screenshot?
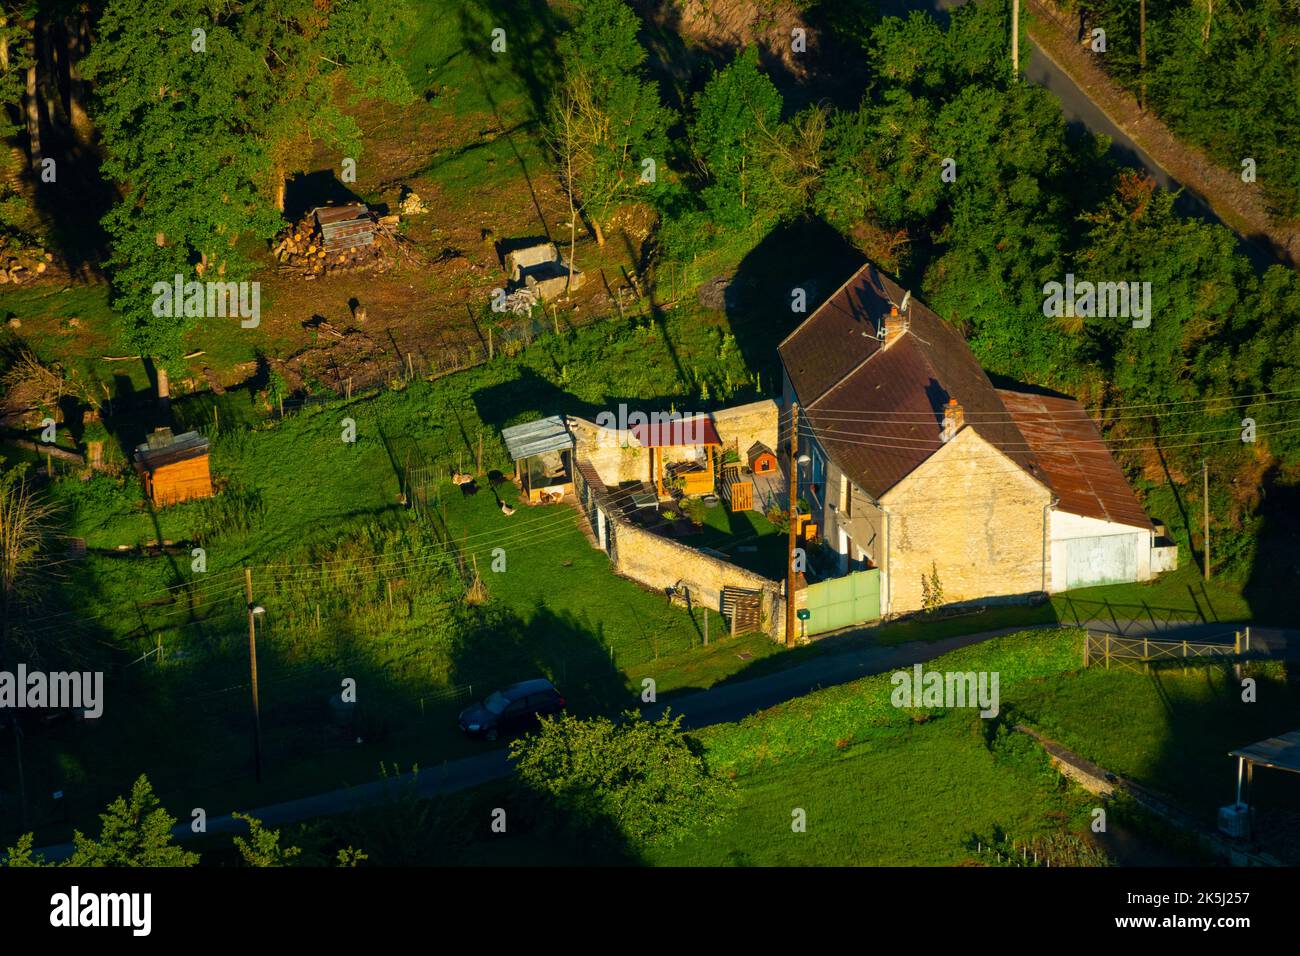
[82,0,412,399]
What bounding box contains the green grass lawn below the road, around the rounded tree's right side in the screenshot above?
[340,631,1112,866]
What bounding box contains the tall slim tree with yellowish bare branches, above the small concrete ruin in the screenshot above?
[547,0,673,246]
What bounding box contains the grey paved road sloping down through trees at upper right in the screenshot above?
[878,0,1279,271]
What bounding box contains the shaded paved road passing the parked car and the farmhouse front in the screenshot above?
[30,618,1300,861]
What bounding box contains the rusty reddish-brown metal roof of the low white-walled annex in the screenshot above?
[997,389,1152,529]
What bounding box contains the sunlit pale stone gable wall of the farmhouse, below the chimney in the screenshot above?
[881,427,1052,614]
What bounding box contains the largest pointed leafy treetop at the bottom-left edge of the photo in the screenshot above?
[68,774,199,866]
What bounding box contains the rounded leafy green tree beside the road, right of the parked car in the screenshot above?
[510,710,733,844]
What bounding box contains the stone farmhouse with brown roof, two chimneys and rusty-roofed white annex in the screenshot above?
[780,263,1177,618]
